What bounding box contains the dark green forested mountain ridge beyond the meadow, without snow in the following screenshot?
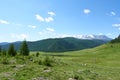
[2,37,108,52]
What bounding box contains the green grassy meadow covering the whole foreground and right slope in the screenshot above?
[0,44,120,80]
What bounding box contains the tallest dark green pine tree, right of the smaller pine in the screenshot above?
[20,40,29,56]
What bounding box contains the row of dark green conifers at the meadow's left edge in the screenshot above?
[0,40,29,56]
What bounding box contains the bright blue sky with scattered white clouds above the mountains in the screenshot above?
[0,0,120,42]
